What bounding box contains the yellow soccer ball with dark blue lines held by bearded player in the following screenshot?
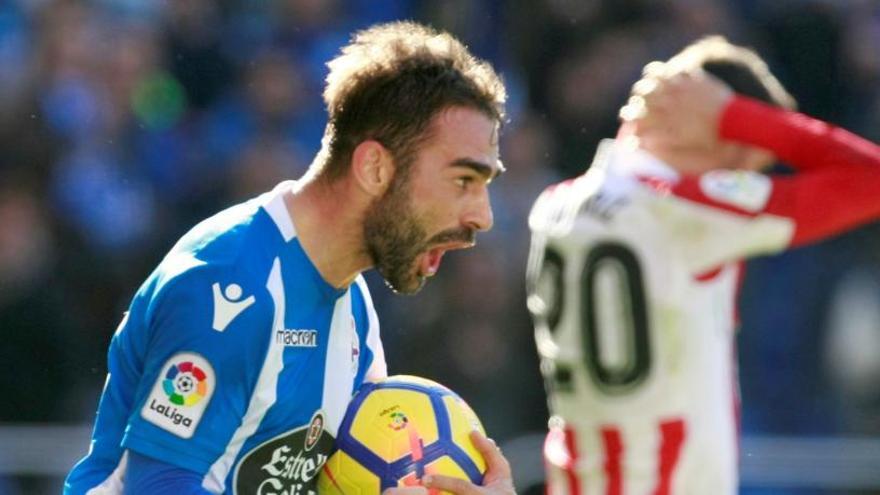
[318,375,486,495]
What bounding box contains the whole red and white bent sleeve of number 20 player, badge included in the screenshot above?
[658,97,880,272]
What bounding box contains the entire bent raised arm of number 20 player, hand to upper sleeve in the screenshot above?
[622,71,880,263]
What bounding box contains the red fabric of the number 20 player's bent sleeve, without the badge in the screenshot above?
[721,97,880,246]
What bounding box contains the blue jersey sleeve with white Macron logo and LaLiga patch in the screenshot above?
[122,265,274,474]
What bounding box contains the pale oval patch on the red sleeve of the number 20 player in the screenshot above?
[700,170,772,213]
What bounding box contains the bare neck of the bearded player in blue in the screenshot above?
[284,179,372,289]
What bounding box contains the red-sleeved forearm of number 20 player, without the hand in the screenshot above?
[719,96,880,170]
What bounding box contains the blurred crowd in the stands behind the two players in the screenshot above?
[0,0,880,494]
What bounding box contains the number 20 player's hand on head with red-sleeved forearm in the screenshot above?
[621,71,880,170]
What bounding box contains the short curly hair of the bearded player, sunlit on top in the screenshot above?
[311,22,506,182]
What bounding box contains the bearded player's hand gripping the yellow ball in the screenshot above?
[382,431,516,495]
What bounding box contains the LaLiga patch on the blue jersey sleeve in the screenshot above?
[141,352,217,438]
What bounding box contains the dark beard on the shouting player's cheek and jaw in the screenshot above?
[364,170,428,294]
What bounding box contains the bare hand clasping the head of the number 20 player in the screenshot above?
[620,62,733,153]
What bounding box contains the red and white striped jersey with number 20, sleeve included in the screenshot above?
[528,98,880,495]
